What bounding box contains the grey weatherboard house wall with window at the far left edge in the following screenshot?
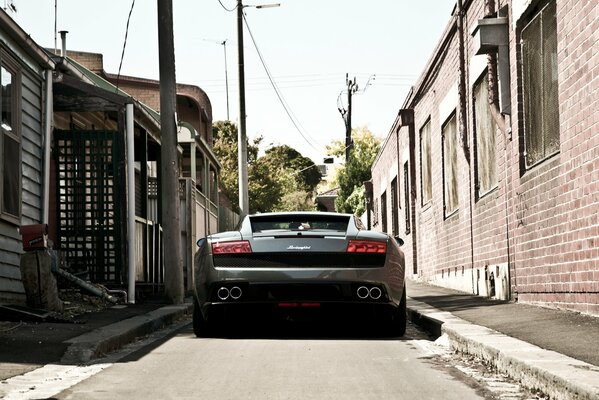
[0,10,55,303]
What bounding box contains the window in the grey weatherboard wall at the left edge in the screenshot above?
[0,51,21,224]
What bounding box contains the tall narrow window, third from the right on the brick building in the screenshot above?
[442,113,458,217]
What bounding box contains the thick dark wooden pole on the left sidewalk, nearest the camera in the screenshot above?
[157,0,184,304]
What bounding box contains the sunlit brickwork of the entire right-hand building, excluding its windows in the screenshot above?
[372,0,599,315]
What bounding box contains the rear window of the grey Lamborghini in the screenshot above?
[250,215,349,233]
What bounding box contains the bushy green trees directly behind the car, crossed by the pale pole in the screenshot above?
[212,121,321,213]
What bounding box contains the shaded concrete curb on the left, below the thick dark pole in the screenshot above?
[60,303,193,364]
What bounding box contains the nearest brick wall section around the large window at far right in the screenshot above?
[512,0,599,315]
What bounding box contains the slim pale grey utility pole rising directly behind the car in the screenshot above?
[237,0,250,217]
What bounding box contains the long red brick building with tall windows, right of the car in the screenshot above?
[372,0,599,315]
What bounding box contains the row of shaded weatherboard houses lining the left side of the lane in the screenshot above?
[0,10,225,303]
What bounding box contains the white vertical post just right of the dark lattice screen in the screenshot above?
[125,104,135,304]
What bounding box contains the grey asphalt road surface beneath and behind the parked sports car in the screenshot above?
[3,324,540,400]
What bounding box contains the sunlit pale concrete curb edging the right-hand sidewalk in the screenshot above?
[408,297,599,400]
